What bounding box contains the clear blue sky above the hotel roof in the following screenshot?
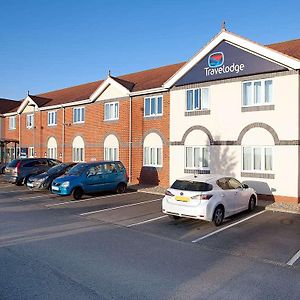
[0,0,300,100]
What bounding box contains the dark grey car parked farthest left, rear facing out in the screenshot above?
[4,158,61,185]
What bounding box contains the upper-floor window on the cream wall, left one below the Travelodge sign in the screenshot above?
[186,88,209,111]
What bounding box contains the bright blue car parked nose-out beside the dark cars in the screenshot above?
[51,161,128,200]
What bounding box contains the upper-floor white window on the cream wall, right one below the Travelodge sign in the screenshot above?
[243,79,273,106]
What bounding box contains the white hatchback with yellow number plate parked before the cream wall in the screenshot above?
[162,174,257,226]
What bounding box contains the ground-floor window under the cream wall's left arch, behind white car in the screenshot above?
[185,146,209,170]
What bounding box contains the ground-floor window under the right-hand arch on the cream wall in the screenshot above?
[243,146,273,172]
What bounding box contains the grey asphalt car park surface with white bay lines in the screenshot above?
[0,179,300,300]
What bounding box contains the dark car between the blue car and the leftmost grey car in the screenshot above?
[26,162,76,191]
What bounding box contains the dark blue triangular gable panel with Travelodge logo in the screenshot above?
[175,41,288,86]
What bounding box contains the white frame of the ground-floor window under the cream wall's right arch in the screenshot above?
[241,145,275,174]
